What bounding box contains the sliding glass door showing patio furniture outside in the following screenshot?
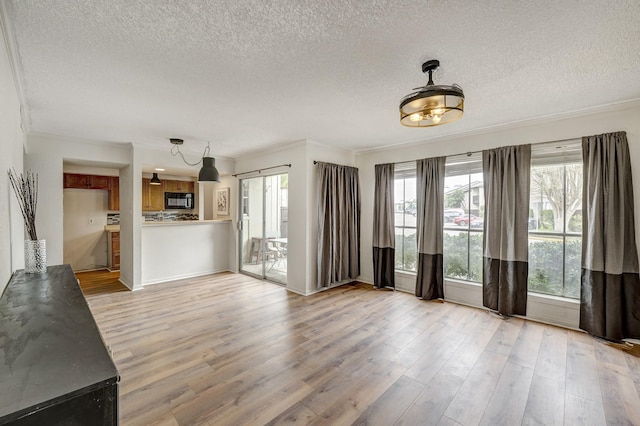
[239,173,289,284]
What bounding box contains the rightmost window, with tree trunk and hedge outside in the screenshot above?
[529,144,582,298]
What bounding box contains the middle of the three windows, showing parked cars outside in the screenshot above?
[443,153,484,282]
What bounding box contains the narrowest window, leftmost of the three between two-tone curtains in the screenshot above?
[393,162,418,272]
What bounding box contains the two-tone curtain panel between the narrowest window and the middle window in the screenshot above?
[416,157,446,300]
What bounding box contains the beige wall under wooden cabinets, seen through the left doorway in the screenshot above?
[63,188,109,271]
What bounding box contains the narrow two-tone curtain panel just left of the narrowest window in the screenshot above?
[373,164,396,288]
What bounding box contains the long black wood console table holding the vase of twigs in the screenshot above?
[0,265,120,425]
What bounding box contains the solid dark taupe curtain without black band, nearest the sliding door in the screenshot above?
[316,162,360,288]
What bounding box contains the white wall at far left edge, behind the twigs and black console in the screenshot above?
[0,15,26,294]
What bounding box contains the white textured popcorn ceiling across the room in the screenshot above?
[5,0,640,157]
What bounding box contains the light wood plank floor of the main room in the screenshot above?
[78,274,640,425]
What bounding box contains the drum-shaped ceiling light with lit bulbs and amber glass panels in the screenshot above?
[400,59,464,127]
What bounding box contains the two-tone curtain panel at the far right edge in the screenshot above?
[580,132,640,341]
